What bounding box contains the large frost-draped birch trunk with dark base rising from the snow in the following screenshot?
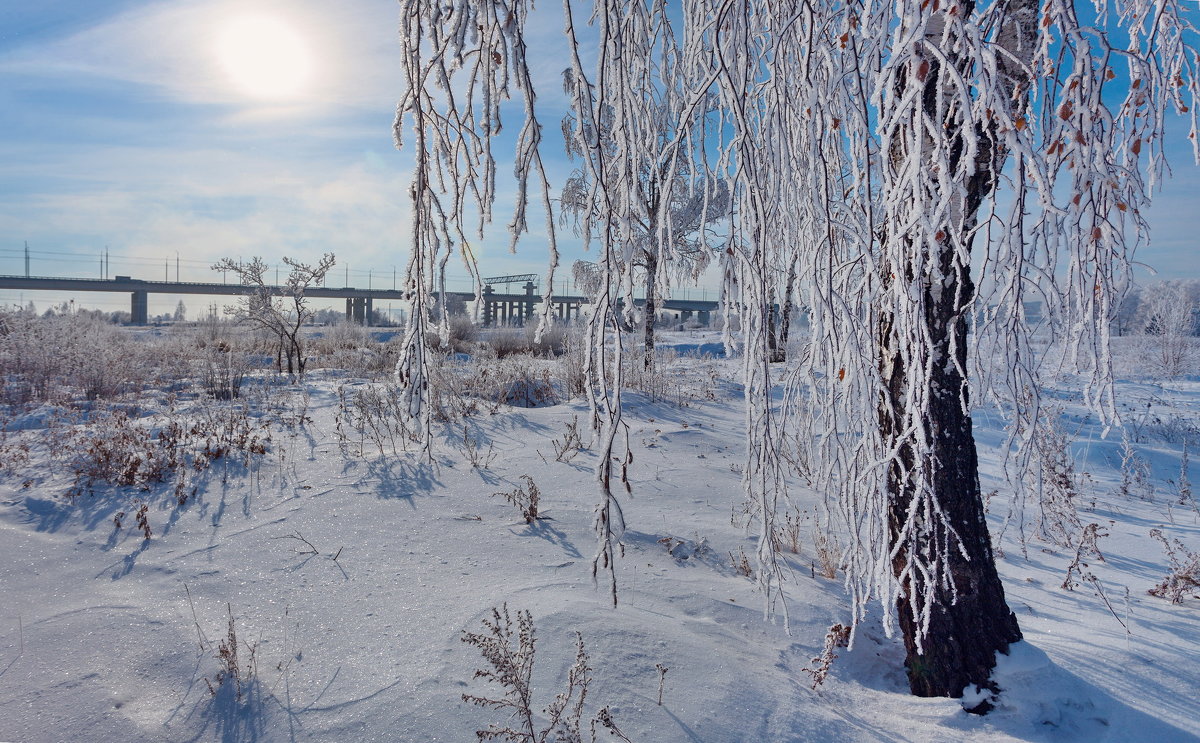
[878,0,1037,713]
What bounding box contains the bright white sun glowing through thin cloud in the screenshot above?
[217,16,313,101]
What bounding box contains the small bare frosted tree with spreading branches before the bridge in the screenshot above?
[212,253,334,377]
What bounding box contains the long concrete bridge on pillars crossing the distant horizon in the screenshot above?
[0,275,716,326]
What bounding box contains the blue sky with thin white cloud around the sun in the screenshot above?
[0,0,1200,311]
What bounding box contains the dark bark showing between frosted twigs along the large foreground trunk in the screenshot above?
[880,0,1037,713]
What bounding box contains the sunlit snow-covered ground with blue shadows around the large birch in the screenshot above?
[0,334,1200,743]
